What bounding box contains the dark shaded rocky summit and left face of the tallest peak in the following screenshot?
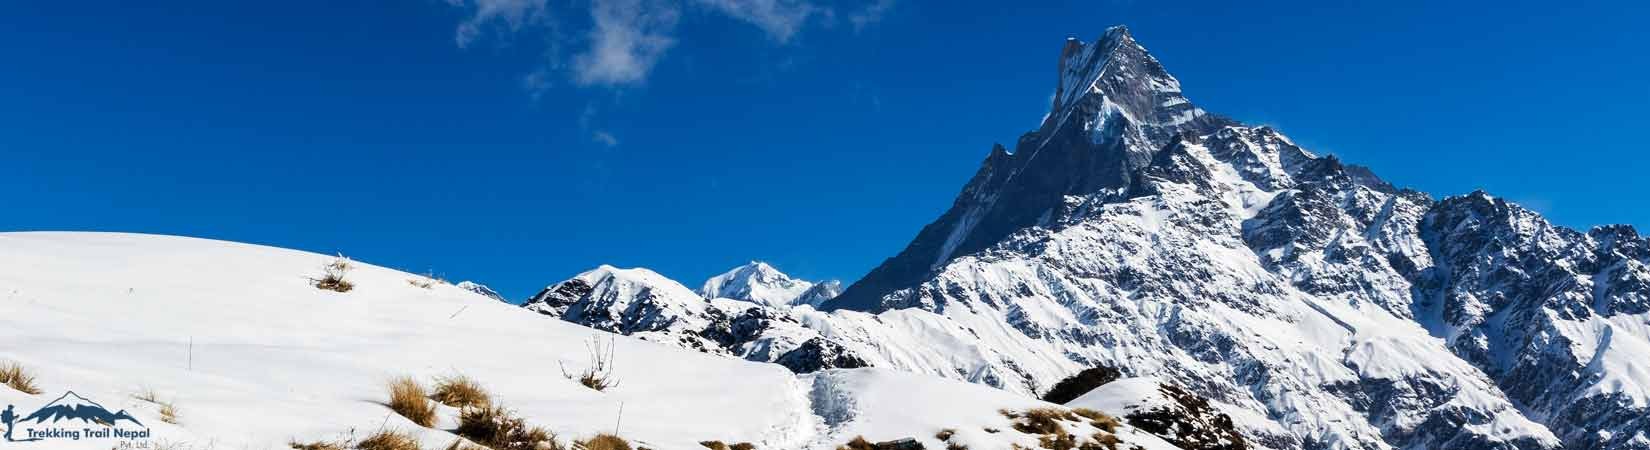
[825,26,1233,310]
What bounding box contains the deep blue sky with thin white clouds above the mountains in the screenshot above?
[0,0,1650,298]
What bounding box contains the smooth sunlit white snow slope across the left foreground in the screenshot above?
[0,232,1172,448]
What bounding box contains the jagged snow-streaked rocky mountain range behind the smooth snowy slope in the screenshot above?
[526,26,1650,450]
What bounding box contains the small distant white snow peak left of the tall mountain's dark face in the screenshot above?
[700,260,840,307]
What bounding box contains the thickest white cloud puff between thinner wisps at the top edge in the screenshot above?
[573,0,681,86]
